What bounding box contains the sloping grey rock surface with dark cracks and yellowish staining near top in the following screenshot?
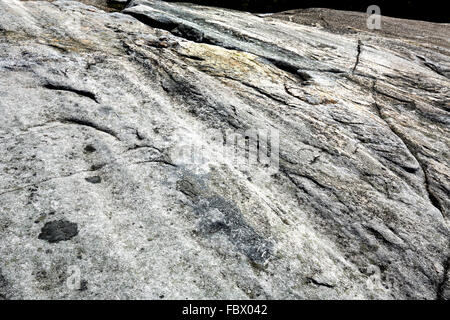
[0,0,450,299]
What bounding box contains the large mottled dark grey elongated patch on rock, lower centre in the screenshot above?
[195,196,273,264]
